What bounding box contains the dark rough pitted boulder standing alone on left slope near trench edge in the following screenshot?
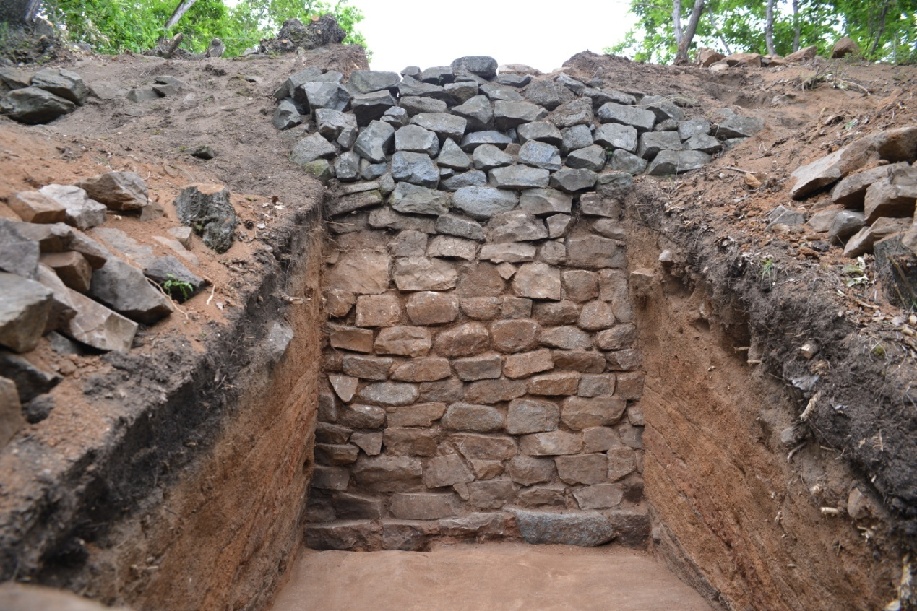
[175,185,239,253]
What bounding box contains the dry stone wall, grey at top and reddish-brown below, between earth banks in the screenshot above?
[274,57,762,549]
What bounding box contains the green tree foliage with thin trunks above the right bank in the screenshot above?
[605,0,917,63]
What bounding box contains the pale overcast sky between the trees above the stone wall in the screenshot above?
[351,0,633,72]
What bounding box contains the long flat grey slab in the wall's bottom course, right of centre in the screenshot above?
[513,509,616,547]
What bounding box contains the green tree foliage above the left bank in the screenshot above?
[44,0,366,57]
